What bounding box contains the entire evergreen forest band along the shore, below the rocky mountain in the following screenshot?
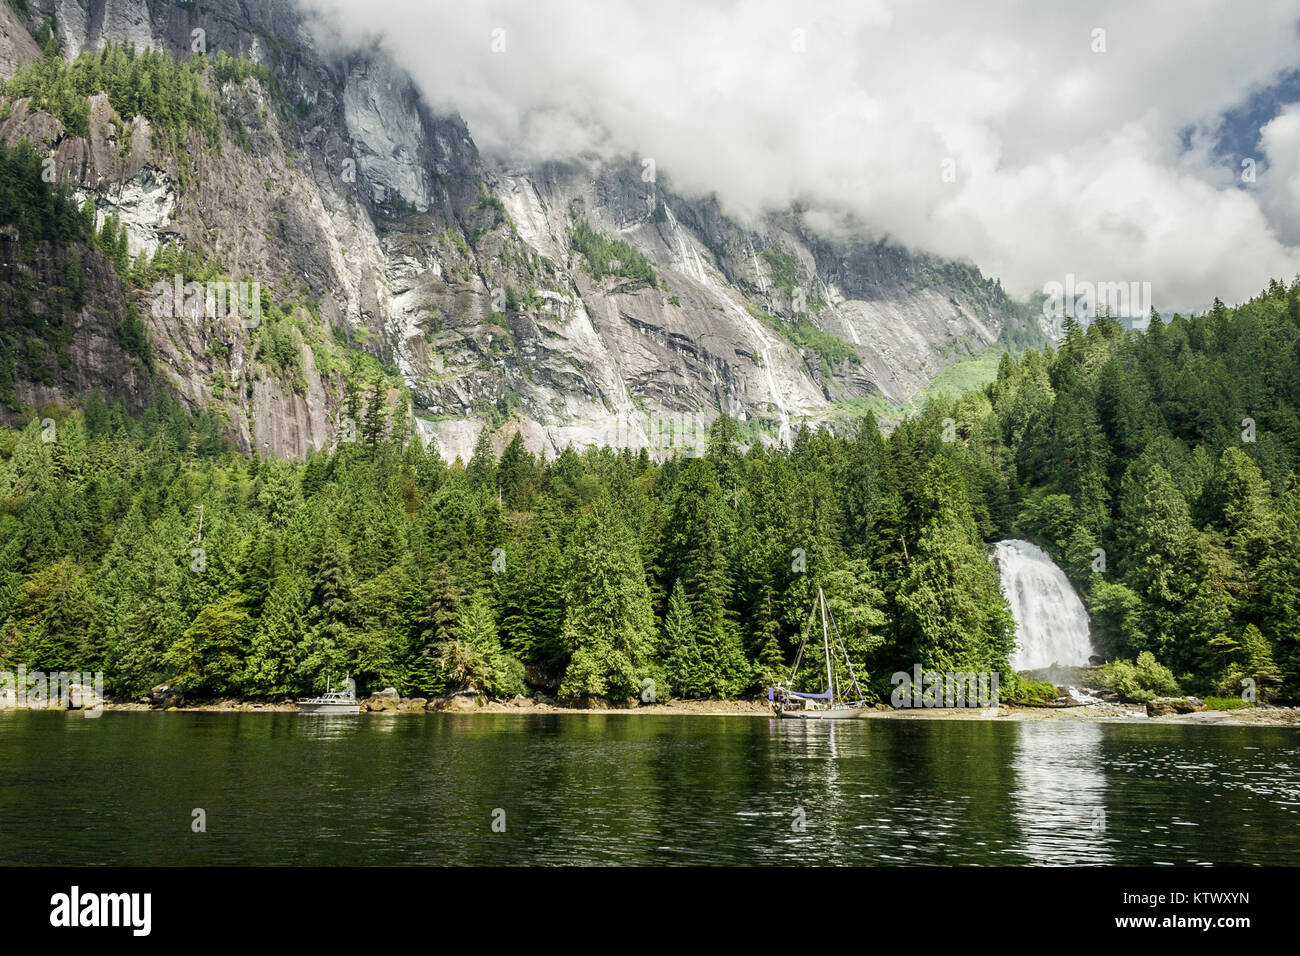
[0,284,1300,698]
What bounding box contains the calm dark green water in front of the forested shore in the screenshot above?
[0,711,1300,865]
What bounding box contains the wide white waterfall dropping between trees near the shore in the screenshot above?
[993,540,1093,671]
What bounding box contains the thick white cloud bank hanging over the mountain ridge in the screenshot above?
[297,0,1300,310]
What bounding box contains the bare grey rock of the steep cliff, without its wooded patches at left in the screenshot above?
[0,0,1034,457]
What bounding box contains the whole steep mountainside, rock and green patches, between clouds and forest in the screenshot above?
[0,0,1041,459]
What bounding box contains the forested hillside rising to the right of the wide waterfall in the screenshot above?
[1008,287,1300,698]
